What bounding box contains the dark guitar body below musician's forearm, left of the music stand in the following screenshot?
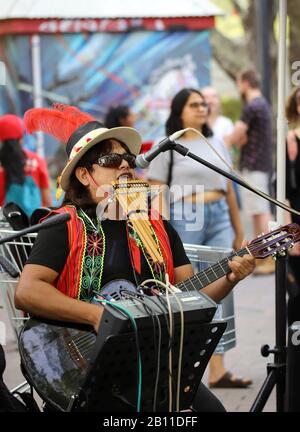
[19,319,96,410]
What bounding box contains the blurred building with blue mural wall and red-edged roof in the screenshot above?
[0,0,222,166]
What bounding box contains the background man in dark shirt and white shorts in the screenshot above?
[225,69,275,274]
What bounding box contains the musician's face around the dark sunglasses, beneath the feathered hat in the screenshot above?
[76,139,134,203]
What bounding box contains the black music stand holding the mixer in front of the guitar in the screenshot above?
[68,321,226,412]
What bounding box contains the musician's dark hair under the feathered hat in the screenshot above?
[62,139,130,214]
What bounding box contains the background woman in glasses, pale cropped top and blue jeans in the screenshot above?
[148,89,251,387]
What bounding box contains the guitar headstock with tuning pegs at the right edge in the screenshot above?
[247,223,300,258]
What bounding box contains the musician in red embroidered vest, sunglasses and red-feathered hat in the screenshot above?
[15,105,255,411]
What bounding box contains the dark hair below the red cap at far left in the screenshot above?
[0,139,26,190]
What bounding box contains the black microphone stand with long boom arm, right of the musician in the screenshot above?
[172,141,289,412]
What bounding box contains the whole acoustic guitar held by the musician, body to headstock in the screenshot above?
[19,224,300,411]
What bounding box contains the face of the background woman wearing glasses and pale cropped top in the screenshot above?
[181,93,208,130]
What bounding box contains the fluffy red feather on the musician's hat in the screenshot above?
[24,104,95,143]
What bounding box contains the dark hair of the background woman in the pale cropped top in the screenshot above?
[166,88,213,137]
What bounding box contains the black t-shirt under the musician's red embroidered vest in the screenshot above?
[27,220,190,286]
